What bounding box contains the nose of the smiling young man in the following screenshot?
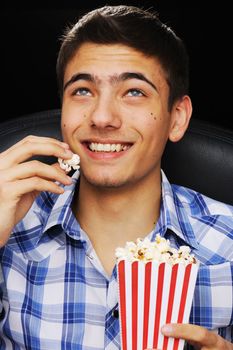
[90,96,122,129]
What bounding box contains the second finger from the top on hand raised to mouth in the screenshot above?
[1,160,72,185]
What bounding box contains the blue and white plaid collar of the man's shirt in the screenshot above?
[42,170,198,248]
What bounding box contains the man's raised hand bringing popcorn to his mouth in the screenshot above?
[0,136,72,246]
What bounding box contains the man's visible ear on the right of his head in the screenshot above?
[169,95,192,142]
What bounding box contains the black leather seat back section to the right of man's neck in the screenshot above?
[162,119,233,205]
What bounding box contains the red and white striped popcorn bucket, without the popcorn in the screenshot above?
[117,260,199,350]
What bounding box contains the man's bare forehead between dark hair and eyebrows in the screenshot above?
[64,43,166,87]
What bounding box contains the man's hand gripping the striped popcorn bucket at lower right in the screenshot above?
[156,324,233,350]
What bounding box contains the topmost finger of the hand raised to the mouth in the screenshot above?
[0,139,73,169]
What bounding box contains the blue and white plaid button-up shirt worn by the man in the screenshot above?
[0,173,233,350]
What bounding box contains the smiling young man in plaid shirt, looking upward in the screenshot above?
[0,6,233,350]
